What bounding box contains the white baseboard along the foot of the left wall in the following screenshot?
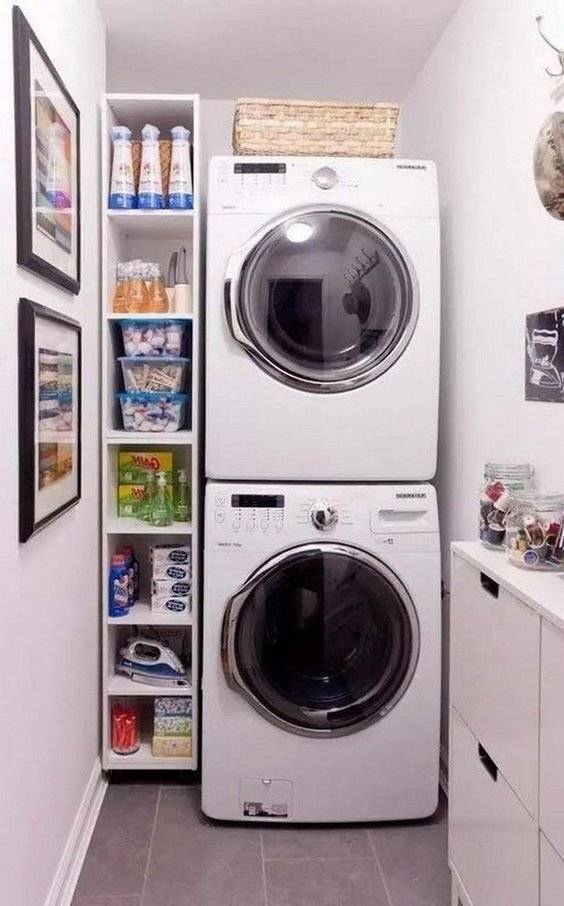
[44,758,108,906]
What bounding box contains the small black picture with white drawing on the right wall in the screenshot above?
[525,308,564,403]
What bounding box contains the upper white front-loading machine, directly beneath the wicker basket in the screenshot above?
[206,157,440,481]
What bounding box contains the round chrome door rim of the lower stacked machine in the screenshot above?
[221,542,421,738]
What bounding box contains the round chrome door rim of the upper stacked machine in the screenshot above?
[225,204,420,393]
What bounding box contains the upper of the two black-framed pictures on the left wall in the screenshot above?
[13,6,80,294]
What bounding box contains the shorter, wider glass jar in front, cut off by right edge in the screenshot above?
[505,494,564,570]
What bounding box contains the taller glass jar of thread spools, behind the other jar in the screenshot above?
[479,462,534,550]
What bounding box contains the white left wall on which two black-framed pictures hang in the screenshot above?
[0,0,105,906]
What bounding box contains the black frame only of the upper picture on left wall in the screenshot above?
[12,6,81,295]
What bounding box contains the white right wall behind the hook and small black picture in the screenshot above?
[401,0,564,580]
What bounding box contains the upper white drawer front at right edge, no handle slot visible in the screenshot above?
[540,620,564,856]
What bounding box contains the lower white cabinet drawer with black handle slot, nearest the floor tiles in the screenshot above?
[449,709,539,906]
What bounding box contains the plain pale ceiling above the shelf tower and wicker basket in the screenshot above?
[99,0,460,101]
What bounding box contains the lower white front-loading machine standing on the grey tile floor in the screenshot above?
[202,482,441,822]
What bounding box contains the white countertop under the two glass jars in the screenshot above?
[451,541,564,630]
